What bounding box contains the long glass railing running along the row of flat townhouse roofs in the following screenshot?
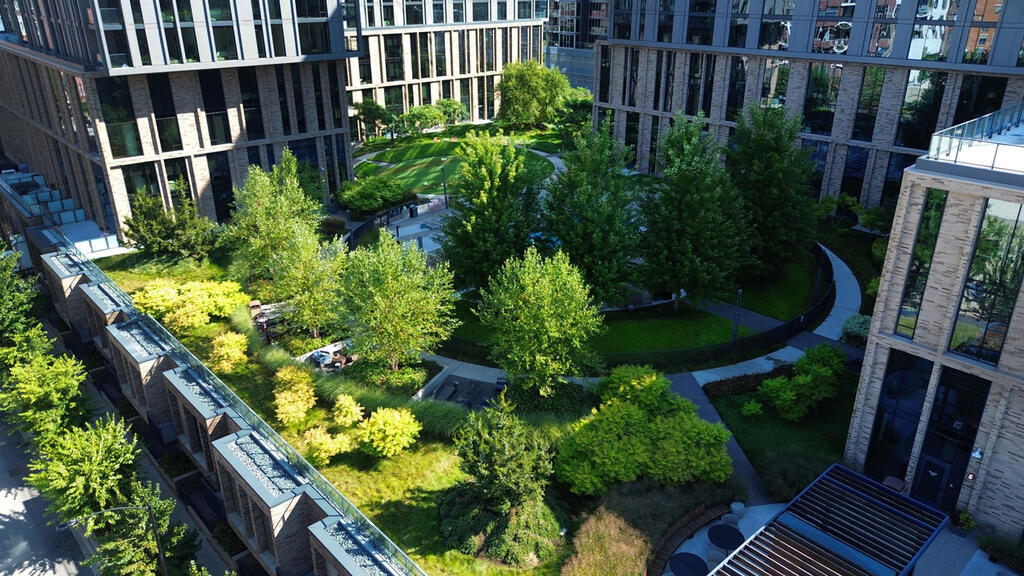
[57,233,426,576]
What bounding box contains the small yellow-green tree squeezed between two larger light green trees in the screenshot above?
[275,233,348,338]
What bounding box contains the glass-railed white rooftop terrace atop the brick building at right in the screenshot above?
[926,102,1024,173]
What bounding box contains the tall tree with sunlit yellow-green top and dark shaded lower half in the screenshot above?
[441,132,540,287]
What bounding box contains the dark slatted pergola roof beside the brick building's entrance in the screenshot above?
[712,464,949,576]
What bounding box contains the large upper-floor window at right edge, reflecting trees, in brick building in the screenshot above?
[949,199,1024,364]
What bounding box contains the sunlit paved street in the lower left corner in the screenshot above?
[0,421,81,576]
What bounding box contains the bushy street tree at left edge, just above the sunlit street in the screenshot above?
[0,355,85,444]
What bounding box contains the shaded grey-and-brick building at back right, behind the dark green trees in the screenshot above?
[595,0,1024,206]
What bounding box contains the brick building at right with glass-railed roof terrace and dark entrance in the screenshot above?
[846,105,1024,539]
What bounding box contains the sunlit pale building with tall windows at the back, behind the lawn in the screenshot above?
[347,0,548,131]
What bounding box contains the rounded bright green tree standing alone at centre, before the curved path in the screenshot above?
[477,247,602,397]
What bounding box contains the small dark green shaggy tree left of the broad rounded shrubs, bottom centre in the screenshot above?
[455,396,552,513]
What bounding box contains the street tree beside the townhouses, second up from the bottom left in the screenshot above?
[27,416,139,530]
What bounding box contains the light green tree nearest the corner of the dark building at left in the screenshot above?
[222,149,321,291]
